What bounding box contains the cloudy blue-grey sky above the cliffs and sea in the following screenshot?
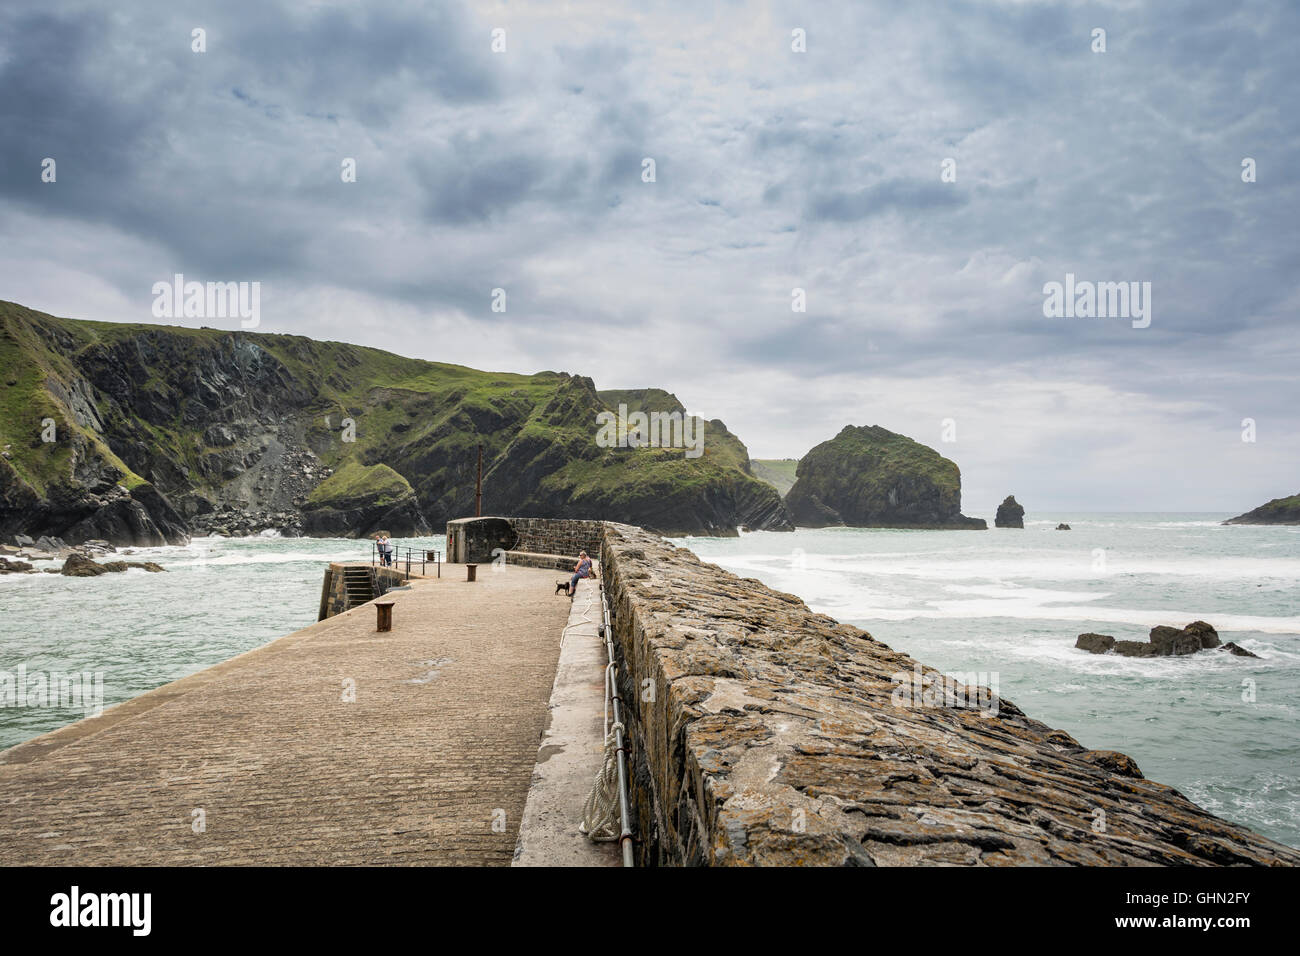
[0,0,1300,519]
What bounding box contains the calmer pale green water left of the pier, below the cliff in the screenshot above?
[0,536,443,749]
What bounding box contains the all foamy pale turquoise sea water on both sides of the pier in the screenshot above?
[0,514,1300,845]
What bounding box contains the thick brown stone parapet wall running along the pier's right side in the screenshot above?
[601,523,1300,866]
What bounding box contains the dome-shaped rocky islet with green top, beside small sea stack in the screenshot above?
[785,425,988,528]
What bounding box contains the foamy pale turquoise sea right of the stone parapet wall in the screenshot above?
[677,514,1300,845]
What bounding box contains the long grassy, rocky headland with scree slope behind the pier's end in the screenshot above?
[0,302,789,545]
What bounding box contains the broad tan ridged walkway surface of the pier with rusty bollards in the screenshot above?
[0,566,569,865]
